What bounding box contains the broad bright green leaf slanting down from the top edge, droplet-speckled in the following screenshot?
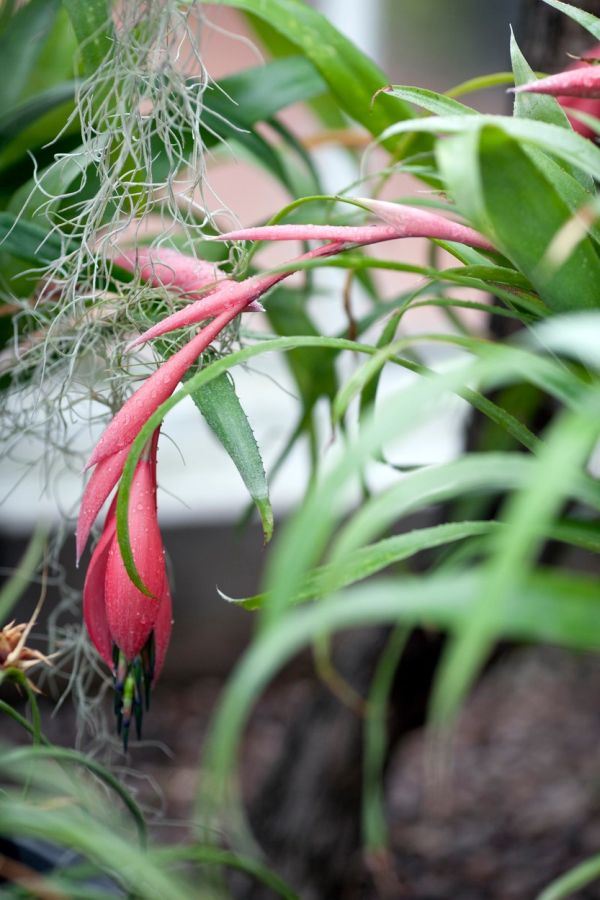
[197,0,410,141]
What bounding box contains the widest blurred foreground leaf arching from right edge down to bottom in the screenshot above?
[197,569,600,828]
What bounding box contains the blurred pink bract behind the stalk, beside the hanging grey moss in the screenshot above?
[114,247,225,297]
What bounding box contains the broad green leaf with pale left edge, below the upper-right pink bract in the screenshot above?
[439,123,600,312]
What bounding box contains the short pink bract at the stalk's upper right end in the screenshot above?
[356,197,494,250]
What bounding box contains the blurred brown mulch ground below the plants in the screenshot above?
[3,648,600,900]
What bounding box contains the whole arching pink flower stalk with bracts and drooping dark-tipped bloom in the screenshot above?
[77,199,494,741]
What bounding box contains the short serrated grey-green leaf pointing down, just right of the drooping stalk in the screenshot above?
[191,374,273,542]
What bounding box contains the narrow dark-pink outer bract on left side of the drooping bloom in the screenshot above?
[83,502,116,668]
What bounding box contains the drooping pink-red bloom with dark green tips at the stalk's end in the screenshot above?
[83,430,172,746]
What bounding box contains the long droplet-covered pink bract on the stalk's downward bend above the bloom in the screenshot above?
[86,304,240,468]
